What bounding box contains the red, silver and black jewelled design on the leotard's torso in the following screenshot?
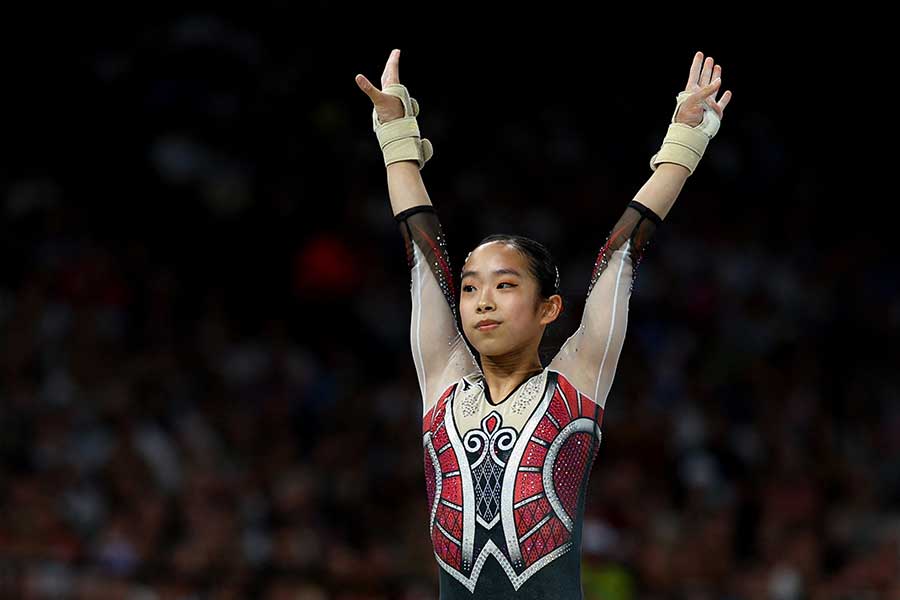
[423,370,603,591]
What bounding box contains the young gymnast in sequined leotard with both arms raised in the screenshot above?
[356,50,731,600]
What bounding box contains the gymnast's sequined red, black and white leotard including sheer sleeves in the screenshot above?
[395,201,661,600]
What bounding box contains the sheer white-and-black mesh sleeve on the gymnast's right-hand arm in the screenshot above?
[549,200,662,408]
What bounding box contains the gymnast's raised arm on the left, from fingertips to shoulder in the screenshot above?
[356,50,479,415]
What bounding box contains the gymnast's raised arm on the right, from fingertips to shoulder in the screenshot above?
[550,52,731,407]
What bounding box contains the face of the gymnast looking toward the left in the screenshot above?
[459,242,555,356]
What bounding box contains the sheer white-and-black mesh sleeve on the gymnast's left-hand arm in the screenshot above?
[394,204,479,415]
